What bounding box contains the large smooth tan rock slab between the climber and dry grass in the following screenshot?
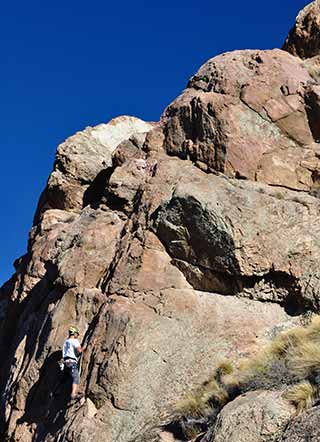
[70,289,288,441]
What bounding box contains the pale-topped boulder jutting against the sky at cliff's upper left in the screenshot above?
[36,116,154,219]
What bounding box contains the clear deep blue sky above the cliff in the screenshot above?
[0,0,308,286]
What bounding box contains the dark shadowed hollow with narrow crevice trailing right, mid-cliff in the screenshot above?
[151,195,312,316]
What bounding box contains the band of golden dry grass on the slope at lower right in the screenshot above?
[177,316,320,430]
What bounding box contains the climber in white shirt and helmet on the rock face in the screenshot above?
[62,326,83,401]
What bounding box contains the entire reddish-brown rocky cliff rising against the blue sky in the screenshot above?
[0,0,320,442]
